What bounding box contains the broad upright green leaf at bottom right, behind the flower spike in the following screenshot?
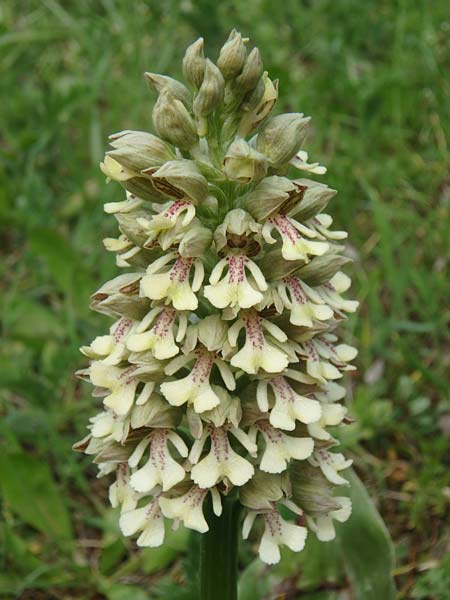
[336,469,396,600]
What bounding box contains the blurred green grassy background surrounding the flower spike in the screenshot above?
[0,0,450,600]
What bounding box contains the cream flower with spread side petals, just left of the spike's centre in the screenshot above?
[161,347,236,413]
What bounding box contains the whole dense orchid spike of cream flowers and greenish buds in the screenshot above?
[75,31,357,563]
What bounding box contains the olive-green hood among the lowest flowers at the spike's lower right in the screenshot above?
[289,461,341,517]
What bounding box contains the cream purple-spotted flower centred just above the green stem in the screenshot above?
[189,425,256,488]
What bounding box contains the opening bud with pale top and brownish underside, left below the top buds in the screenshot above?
[144,159,208,204]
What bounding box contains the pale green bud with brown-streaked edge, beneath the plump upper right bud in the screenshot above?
[241,175,304,221]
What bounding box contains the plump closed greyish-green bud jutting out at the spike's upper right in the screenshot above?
[256,113,310,168]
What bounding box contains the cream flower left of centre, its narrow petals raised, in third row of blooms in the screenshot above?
[126,306,187,360]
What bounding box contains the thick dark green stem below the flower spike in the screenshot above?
[200,498,240,600]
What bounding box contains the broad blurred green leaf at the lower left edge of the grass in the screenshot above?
[0,453,72,546]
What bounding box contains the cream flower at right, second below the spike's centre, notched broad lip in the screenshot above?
[256,375,322,431]
